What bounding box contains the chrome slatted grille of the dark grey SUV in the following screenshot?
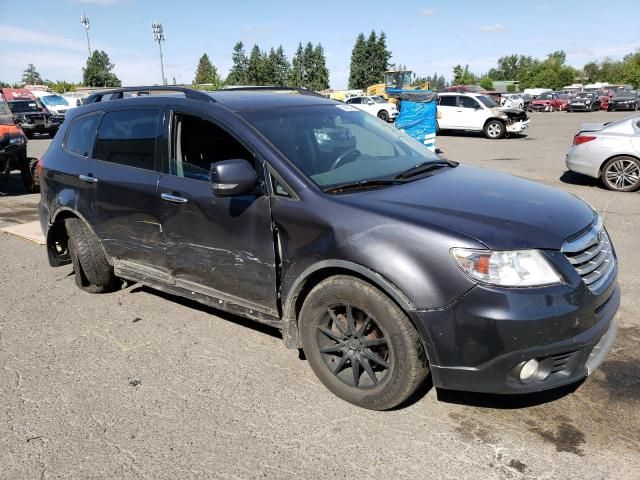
[562,218,616,292]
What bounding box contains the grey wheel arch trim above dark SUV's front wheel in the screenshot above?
[282,260,415,348]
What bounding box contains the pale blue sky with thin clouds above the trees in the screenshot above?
[0,0,640,88]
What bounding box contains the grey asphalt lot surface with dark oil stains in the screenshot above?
[0,112,640,480]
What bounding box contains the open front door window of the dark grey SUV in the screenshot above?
[169,113,255,182]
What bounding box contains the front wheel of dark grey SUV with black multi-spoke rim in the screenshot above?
[300,275,429,410]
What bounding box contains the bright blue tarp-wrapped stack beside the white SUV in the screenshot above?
[396,92,436,151]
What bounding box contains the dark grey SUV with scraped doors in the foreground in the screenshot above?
[39,87,620,410]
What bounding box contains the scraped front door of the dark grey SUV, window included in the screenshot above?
[158,108,277,315]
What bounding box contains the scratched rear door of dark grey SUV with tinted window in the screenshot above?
[87,106,168,280]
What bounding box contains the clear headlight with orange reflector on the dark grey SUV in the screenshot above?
[451,248,562,287]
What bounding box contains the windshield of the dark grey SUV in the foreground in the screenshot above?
[241,105,441,189]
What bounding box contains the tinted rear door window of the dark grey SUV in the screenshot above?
[93,110,160,170]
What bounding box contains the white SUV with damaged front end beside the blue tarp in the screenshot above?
[438,92,529,139]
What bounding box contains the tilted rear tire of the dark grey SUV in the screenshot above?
[65,218,118,293]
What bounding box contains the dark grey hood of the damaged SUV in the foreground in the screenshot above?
[337,165,595,250]
